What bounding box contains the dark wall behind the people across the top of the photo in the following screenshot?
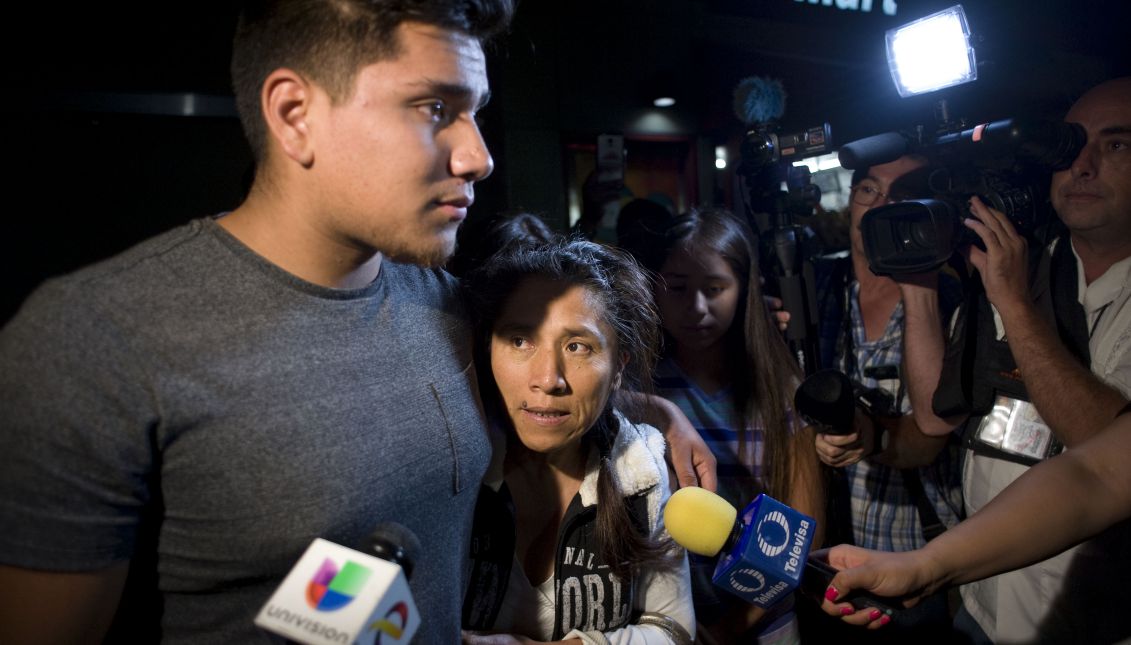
[0,0,1131,320]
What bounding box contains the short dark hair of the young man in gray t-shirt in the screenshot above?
[232,0,515,162]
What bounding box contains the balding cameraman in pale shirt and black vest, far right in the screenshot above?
[900,77,1131,643]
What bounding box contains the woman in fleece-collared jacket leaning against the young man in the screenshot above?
[464,241,694,643]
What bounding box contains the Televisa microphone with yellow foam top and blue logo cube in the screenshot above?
[664,487,893,616]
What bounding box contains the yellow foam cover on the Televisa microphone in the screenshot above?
[664,487,739,557]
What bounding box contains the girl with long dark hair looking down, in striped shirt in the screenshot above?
[649,209,824,643]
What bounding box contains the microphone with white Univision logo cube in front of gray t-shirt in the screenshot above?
[256,522,421,645]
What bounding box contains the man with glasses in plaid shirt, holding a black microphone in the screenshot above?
[815,155,961,642]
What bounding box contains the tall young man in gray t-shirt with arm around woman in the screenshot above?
[0,0,512,643]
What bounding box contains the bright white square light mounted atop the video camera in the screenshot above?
[887,5,978,97]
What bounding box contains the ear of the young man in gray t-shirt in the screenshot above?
[260,68,319,167]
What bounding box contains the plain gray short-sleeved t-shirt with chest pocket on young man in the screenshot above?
[0,220,490,643]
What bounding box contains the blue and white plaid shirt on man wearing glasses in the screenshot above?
[820,259,962,551]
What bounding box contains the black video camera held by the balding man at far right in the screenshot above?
[839,119,1086,275]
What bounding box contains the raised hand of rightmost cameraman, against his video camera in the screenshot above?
[964,197,1029,316]
